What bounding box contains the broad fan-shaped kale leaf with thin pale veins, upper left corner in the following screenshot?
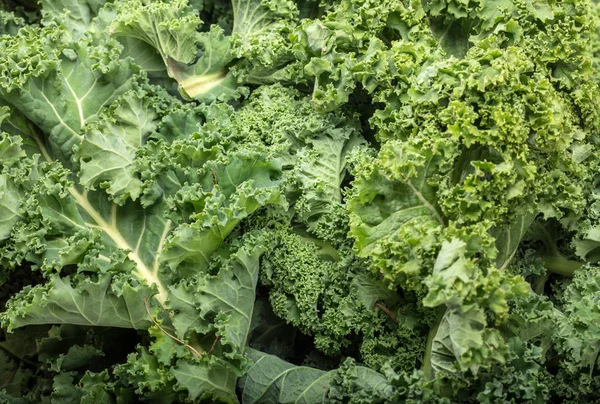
[0,28,136,163]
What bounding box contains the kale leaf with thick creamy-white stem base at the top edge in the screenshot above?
[110,0,297,103]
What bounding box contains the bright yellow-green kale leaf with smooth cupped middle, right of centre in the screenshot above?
[348,142,444,287]
